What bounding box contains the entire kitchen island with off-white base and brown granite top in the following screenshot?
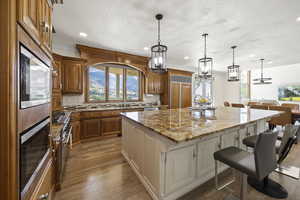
[122,107,280,200]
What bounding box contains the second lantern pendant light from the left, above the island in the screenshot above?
[195,33,213,80]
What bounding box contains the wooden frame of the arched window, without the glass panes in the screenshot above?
[85,63,144,103]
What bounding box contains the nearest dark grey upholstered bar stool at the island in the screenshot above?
[214,131,277,200]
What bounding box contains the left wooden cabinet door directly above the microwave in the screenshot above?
[18,0,41,43]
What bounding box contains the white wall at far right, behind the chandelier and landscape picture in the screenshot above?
[251,63,300,103]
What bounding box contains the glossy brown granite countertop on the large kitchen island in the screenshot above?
[121,107,281,142]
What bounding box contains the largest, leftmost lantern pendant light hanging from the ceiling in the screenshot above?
[149,14,168,73]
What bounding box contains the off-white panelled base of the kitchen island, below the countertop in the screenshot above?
[122,117,266,200]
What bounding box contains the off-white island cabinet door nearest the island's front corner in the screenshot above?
[165,145,197,194]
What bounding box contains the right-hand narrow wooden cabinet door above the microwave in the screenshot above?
[40,0,52,52]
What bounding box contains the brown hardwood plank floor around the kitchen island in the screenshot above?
[55,137,300,200]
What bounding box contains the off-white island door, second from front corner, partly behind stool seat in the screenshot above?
[197,136,220,180]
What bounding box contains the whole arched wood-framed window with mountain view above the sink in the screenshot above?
[86,63,142,103]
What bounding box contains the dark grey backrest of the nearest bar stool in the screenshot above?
[254,131,278,180]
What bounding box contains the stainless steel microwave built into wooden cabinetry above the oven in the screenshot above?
[19,45,51,109]
